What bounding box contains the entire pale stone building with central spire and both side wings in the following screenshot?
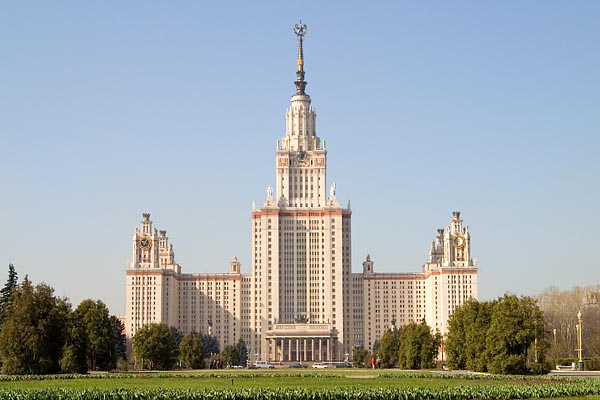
[125,25,477,362]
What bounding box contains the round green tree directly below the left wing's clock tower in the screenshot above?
[133,323,179,370]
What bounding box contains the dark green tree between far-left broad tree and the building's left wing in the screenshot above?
[75,299,118,371]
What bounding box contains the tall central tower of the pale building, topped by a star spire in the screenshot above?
[252,23,351,361]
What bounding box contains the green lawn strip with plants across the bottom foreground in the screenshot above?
[0,369,600,400]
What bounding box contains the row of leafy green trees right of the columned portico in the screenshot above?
[353,294,550,374]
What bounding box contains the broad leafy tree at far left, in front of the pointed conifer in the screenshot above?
[0,278,71,374]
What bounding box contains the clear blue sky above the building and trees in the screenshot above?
[0,1,600,314]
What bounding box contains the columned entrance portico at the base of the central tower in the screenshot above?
[266,324,339,362]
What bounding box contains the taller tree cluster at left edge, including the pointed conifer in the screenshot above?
[0,264,126,374]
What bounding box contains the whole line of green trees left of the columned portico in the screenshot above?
[0,264,248,375]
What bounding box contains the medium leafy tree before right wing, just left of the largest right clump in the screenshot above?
[398,322,441,369]
